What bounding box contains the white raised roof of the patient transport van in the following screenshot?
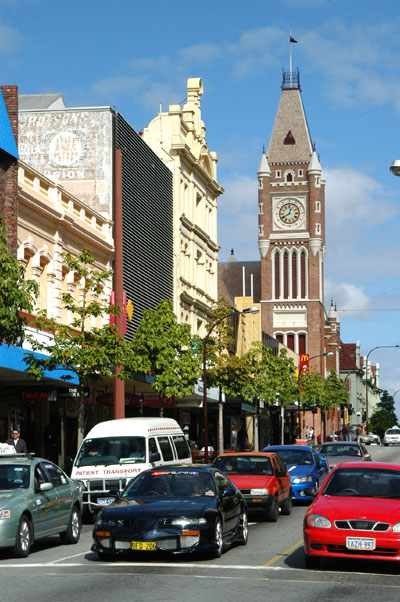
[85,418,182,439]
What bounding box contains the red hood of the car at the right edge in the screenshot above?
[307,495,400,522]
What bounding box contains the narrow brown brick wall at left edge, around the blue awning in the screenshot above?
[0,86,18,256]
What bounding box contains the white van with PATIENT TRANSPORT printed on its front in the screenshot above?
[71,418,192,514]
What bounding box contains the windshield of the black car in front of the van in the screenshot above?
[122,470,215,499]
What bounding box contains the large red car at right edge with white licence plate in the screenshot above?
[304,462,400,568]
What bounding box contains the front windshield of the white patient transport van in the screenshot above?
[75,437,146,466]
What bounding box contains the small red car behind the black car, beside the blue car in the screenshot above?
[213,452,292,522]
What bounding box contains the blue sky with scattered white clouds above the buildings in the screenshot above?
[0,0,400,408]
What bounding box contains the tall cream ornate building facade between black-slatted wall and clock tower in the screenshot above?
[141,78,223,337]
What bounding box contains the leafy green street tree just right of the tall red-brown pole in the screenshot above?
[130,300,201,416]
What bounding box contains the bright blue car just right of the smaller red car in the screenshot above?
[262,445,329,500]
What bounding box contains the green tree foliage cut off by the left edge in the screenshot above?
[0,219,39,345]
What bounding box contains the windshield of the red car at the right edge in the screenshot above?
[322,468,400,499]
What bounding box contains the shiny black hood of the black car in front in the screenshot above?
[101,496,217,518]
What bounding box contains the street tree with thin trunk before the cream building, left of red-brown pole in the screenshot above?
[25,248,134,447]
